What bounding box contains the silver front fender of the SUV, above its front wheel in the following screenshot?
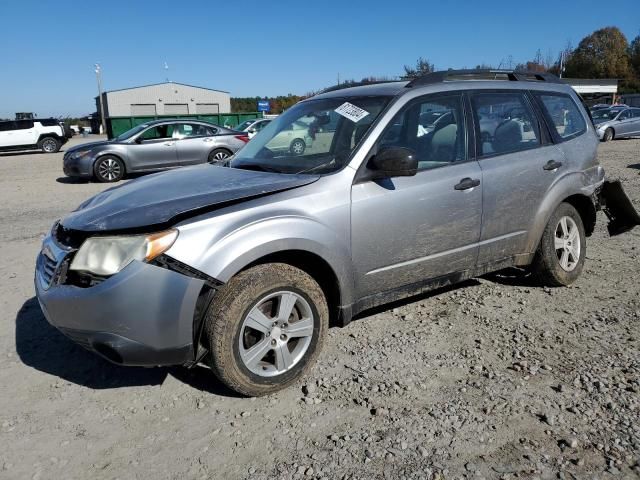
[166,216,354,305]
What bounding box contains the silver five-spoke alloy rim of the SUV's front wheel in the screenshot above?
[238,291,315,377]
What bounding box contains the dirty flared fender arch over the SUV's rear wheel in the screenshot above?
[524,165,604,254]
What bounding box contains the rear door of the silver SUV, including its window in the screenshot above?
[470,90,566,265]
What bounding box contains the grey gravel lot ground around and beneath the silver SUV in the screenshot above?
[0,135,640,479]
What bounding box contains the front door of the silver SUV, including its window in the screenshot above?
[351,94,482,298]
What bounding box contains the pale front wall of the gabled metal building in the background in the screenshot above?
[105,83,231,117]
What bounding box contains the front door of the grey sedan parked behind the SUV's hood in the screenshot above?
[127,123,178,171]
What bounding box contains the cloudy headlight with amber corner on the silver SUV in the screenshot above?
[69,229,178,276]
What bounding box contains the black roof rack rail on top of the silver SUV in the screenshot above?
[406,69,564,88]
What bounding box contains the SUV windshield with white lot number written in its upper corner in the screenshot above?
[230,96,391,174]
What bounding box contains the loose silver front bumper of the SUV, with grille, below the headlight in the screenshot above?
[35,236,205,366]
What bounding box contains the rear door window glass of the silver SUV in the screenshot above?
[471,92,540,156]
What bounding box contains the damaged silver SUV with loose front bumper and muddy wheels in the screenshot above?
[35,71,640,395]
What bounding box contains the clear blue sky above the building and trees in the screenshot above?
[0,0,640,118]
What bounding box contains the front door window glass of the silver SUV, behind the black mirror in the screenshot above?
[378,95,466,170]
